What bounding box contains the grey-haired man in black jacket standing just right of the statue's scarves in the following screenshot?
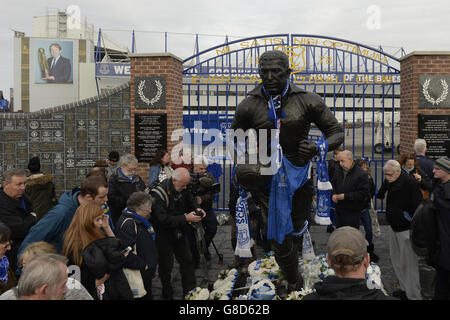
[331,150,370,229]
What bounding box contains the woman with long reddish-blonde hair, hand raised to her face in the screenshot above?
[63,201,133,300]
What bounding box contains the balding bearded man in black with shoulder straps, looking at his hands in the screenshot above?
[151,168,206,300]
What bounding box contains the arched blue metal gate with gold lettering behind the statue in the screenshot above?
[183,34,400,210]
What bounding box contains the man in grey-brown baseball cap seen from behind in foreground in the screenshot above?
[303,226,395,300]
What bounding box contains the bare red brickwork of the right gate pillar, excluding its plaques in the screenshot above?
[400,51,450,153]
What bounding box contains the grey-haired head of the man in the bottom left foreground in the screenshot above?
[17,253,68,300]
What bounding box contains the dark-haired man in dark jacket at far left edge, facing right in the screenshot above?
[0,169,36,271]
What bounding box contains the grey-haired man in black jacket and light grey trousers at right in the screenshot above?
[377,160,422,300]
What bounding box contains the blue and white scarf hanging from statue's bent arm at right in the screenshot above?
[314,137,333,225]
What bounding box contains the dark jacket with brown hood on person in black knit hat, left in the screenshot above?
[25,173,57,221]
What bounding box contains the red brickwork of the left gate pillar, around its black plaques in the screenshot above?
[129,53,183,182]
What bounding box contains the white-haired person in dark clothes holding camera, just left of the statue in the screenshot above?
[188,157,220,268]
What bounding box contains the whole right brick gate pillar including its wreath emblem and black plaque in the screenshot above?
[400,51,450,158]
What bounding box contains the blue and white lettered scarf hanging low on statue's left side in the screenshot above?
[234,186,254,258]
